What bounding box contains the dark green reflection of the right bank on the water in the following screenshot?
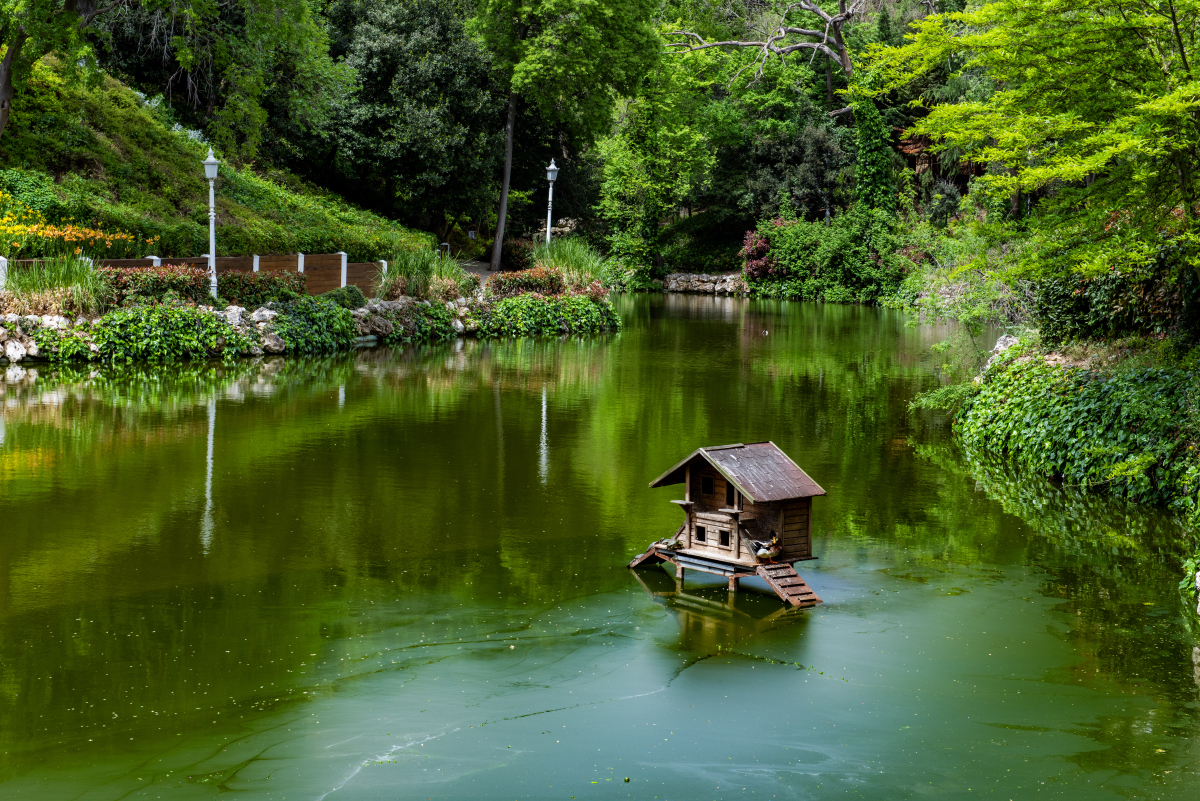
[917,446,1200,770]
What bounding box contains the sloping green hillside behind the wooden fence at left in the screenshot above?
[0,59,433,261]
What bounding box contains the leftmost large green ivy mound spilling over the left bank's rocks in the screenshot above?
[87,306,252,362]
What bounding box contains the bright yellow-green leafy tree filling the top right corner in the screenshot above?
[872,0,1200,273]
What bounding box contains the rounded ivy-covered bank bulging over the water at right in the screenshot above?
[954,337,1200,526]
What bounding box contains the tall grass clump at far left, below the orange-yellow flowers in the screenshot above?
[0,255,109,314]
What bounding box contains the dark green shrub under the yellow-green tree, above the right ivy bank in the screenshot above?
[1033,265,1200,344]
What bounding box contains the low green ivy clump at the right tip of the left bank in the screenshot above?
[479,294,620,337]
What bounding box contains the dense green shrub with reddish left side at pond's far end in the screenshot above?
[744,204,911,303]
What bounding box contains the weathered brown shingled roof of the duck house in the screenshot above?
[650,442,826,504]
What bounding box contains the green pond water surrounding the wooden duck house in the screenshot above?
[0,296,1200,801]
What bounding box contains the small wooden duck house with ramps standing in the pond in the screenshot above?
[629,442,826,607]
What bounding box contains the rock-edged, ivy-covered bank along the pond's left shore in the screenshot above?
[0,280,620,363]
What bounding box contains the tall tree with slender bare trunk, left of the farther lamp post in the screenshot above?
[475,0,660,269]
